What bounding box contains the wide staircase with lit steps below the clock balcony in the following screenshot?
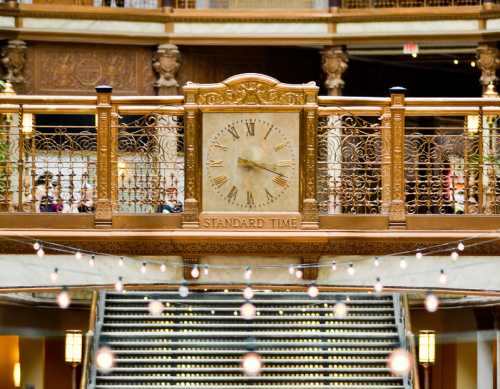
[88,292,411,389]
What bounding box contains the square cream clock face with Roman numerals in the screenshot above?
[203,113,299,212]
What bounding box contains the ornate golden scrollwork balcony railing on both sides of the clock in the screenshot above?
[0,89,500,229]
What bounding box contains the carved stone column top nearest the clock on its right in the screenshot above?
[321,47,349,96]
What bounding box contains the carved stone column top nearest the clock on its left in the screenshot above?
[153,44,181,96]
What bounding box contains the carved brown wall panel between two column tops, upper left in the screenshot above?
[25,43,155,95]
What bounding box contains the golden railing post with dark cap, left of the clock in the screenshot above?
[95,85,113,228]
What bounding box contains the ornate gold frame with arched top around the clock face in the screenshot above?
[182,73,319,229]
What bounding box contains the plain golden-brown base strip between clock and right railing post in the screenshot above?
[319,215,389,230]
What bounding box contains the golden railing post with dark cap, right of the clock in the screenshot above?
[389,87,406,228]
